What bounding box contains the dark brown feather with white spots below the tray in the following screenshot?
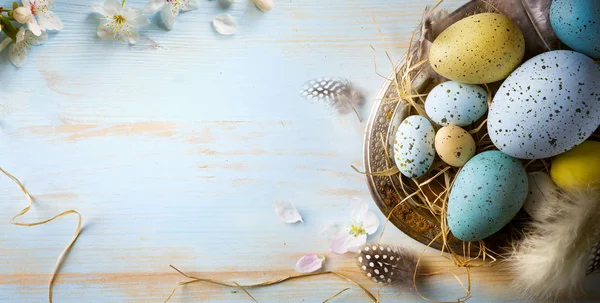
[356,244,417,287]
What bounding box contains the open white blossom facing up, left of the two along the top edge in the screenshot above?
[94,0,150,44]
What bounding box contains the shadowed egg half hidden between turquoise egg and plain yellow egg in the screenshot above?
[523,172,558,219]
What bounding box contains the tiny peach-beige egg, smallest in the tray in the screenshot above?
[435,125,475,167]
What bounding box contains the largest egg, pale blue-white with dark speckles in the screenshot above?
[488,51,600,159]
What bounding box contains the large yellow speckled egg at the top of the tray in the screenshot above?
[429,13,525,84]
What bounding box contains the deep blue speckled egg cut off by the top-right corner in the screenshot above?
[550,0,600,58]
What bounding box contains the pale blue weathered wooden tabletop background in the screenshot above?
[0,0,600,302]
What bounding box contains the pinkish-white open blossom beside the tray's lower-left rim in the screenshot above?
[328,202,379,254]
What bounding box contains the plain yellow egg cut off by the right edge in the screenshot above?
[550,141,600,190]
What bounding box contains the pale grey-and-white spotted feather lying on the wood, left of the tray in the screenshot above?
[301,78,364,120]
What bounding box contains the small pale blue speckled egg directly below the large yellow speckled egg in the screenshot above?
[425,81,487,126]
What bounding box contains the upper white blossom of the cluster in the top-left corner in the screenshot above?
[22,0,63,36]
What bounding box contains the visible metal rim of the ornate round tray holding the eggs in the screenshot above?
[364,1,523,255]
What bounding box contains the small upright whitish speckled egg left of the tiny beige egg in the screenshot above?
[394,116,435,178]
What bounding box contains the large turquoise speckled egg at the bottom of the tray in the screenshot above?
[448,150,529,241]
